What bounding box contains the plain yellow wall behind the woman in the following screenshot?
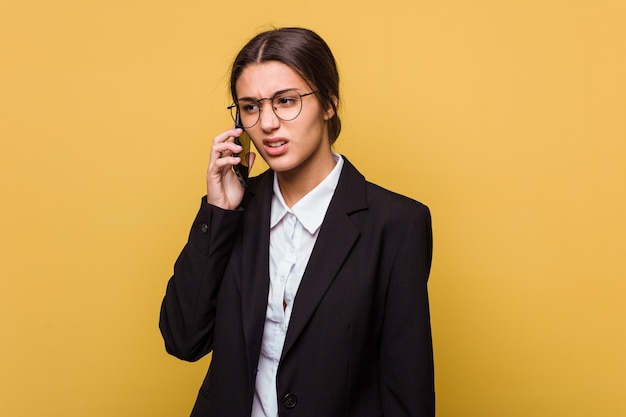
[0,0,626,417]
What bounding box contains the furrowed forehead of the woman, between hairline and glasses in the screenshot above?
[235,61,308,98]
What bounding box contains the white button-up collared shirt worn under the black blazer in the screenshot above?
[251,154,343,417]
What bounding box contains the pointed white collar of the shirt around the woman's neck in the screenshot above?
[270,153,343,234]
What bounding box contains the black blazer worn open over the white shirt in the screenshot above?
[160,158,435,417]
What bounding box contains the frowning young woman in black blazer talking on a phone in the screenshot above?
[160,28,434,417]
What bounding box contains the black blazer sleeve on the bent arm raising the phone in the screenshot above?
[159,198,243,361]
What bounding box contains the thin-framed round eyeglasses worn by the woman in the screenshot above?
[227,89,317,129]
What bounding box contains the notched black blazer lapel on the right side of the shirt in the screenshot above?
[282,157,367,357]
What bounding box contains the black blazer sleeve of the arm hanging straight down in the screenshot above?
[380,205,435,417]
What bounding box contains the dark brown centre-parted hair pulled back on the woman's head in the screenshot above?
[230,28,341,144]
